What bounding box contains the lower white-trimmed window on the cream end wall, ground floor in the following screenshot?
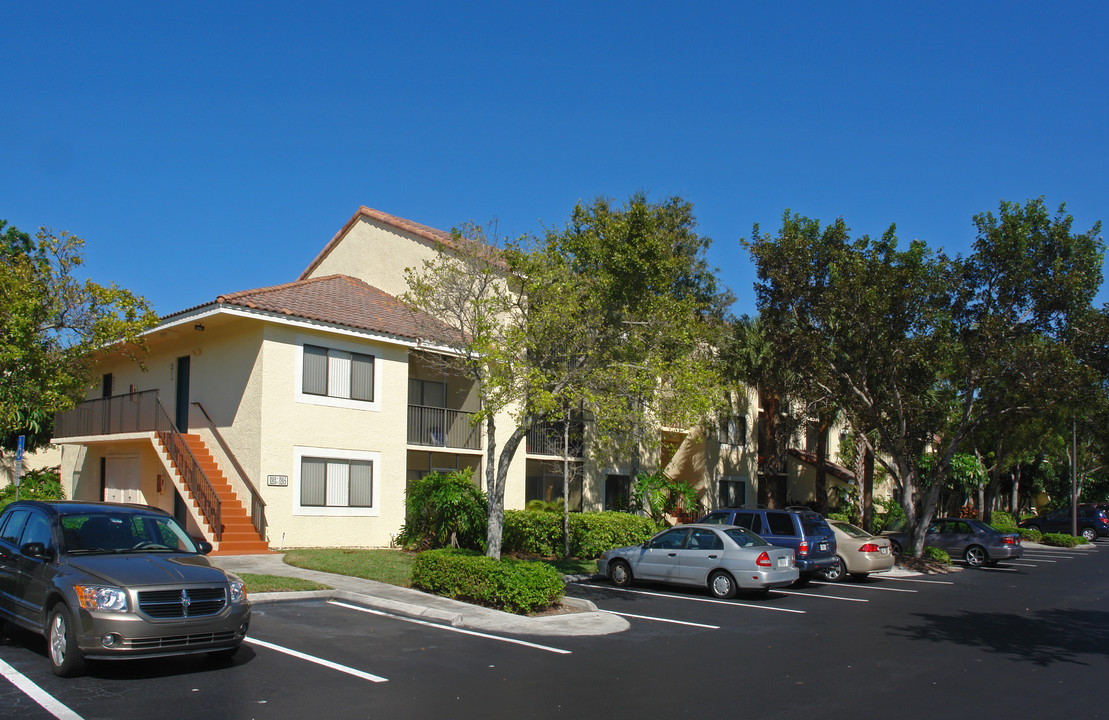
[293,447,380,516]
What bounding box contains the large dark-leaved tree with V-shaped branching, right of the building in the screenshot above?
[745,200,1103,552]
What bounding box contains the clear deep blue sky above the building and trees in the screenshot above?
[0,1,1109,314]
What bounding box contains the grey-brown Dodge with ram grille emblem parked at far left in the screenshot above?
[0,500,251,677]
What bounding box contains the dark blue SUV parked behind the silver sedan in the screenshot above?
[698,508,837,582]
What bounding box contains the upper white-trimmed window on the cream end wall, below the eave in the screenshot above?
[296,336,381,410]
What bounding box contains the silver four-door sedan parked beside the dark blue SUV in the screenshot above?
[597,525,797,598]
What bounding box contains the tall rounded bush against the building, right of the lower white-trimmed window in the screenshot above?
[397,470,488,550]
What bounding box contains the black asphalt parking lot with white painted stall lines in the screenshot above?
[0,541,1109,718]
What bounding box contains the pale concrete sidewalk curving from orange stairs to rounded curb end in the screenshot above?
[208,552,629,636]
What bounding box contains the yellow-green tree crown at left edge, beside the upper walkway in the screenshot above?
[0,221,157,450]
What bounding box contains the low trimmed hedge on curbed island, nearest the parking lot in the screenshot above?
[413,549,566,615]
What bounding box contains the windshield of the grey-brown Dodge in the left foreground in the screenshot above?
[61,513,197,554]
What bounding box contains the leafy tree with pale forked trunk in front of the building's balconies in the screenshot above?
[405,194,726,557]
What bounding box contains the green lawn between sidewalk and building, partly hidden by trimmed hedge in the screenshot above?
[285,548,597,588]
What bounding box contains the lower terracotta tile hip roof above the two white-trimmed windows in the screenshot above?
[216,275,452,342]
